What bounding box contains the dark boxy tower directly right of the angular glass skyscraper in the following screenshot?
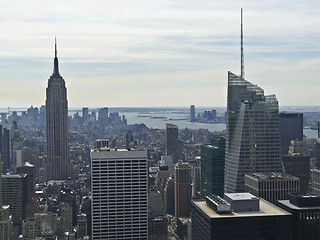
[279,113,303,154]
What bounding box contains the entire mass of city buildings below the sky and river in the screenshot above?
[0,17,320,240]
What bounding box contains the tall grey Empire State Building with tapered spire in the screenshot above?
[46,38,70,180]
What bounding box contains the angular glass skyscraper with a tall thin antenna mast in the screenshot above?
[225,10,282,192]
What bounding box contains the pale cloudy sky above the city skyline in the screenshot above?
[0,0,320,108]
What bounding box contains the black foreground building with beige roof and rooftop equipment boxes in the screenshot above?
[191,193,292,240]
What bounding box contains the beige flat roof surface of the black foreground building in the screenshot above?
[193,198,291,218]
